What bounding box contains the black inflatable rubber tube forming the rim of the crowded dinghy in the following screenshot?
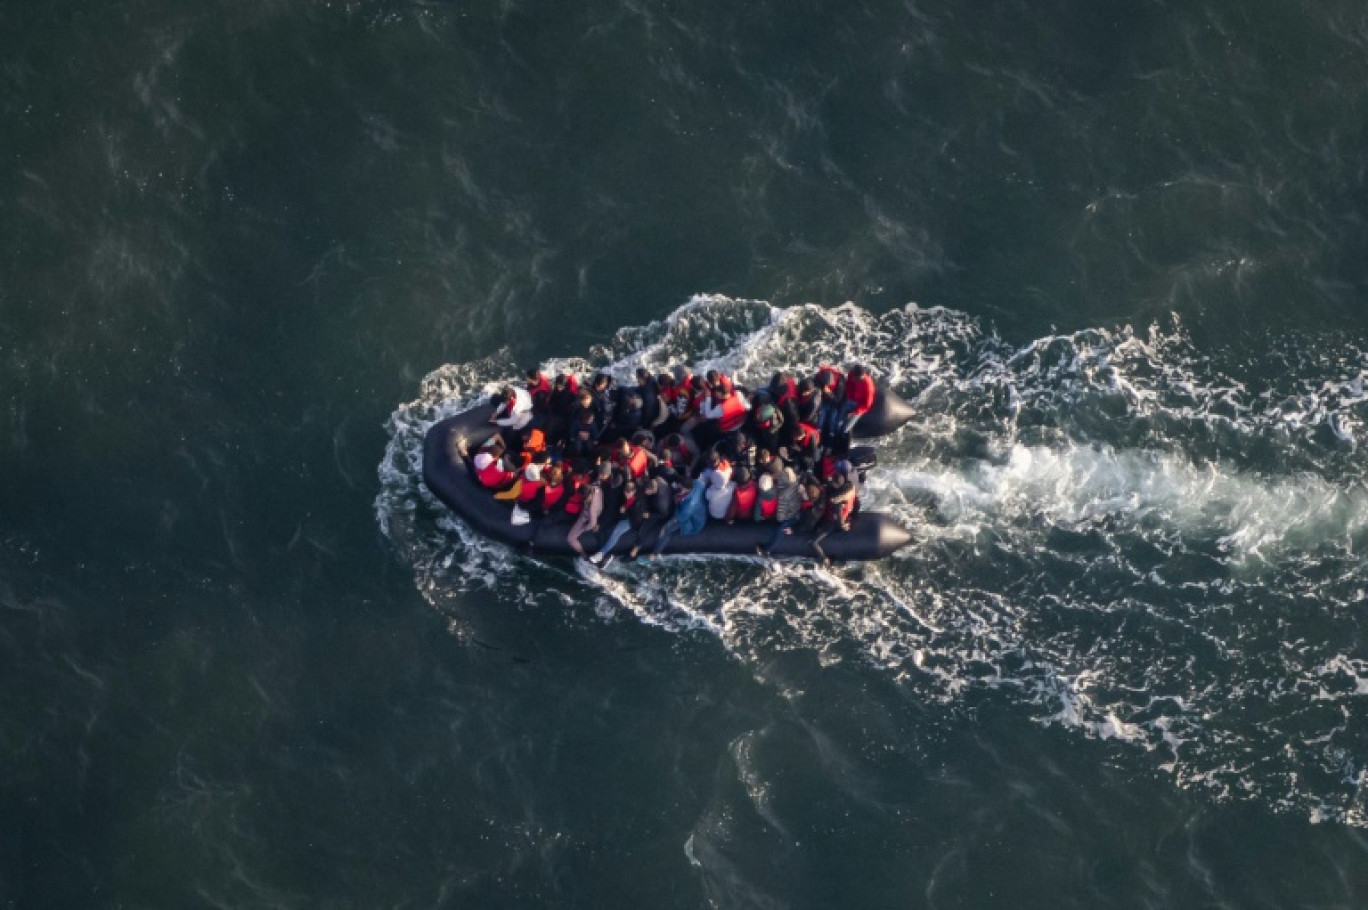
[423,385,912,560]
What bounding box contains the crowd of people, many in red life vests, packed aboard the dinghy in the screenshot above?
[457,365,876,564]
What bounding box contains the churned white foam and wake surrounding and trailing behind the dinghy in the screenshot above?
[376,296,1368,825]
